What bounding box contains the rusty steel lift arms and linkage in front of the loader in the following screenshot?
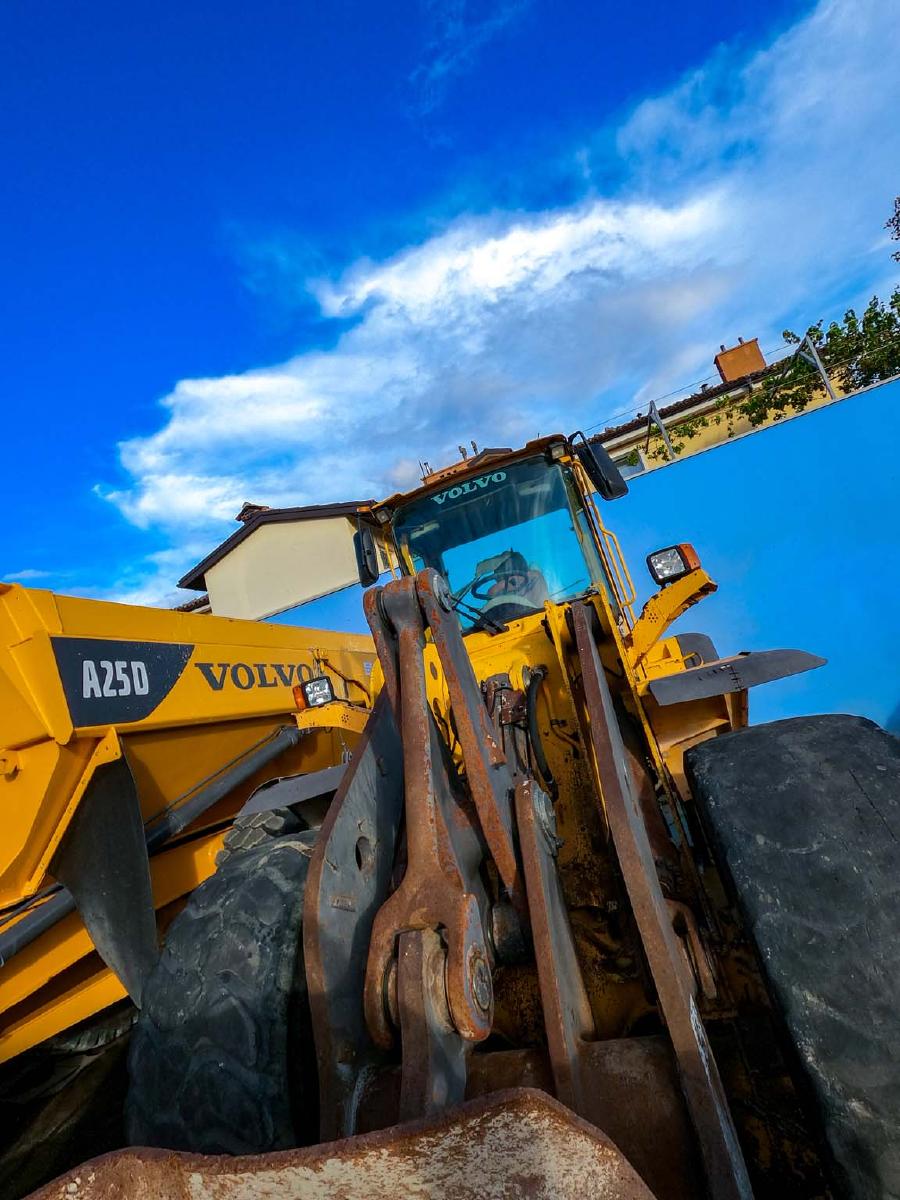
[305,569,750,1200]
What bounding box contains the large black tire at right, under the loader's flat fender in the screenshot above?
[685,716,900,1200]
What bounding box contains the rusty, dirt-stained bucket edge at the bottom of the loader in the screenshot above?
[31,1088,654,1200]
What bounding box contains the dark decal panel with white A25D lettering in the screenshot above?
[50,637,193,728]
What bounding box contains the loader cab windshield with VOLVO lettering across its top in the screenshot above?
[392,457,602,630]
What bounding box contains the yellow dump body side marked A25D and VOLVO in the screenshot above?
[0,587,374,907]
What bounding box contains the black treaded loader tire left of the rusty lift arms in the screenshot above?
[126,833,317,1154]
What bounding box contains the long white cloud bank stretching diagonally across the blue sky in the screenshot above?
[101,0,900,600]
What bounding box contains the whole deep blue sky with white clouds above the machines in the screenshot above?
[0,0,900,628]
